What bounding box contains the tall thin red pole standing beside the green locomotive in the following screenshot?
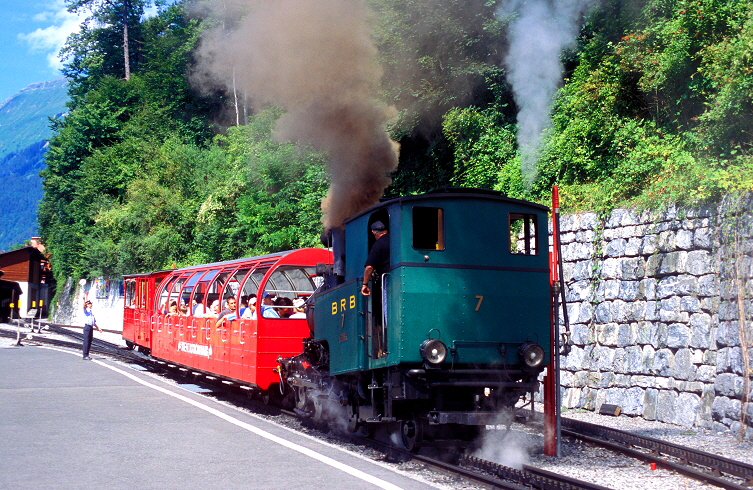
[544,186,560,457]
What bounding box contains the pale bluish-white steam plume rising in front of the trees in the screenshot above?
[499,0,595,183]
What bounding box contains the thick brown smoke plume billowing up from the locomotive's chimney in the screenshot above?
[194,0,397,228]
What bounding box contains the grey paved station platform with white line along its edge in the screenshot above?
[0,346,435,490]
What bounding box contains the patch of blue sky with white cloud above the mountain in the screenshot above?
[0,0,82,103]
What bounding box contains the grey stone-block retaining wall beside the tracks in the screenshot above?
[561,194,753,438]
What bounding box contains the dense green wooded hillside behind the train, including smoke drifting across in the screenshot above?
[39,0,753,292]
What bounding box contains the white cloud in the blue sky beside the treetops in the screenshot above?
[18,0,86,70]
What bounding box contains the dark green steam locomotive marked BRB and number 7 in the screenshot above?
[280,189,551,449]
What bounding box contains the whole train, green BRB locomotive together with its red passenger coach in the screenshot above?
[123,189,550,449]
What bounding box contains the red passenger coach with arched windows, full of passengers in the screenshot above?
[123,248,332,391]
